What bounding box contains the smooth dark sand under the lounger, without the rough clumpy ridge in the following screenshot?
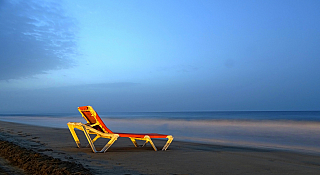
[0,122,320,175]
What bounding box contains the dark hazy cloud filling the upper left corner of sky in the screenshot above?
[0,0,78,80]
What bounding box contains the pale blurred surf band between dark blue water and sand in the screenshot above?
[0,117,320,155]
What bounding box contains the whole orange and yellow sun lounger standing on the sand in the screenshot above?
[68,106,173,153]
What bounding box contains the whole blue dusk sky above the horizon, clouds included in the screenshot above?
[0,0,320,114]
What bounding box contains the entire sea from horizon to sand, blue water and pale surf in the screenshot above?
[0,111,320,155]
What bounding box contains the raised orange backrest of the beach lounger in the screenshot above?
[78,106,113,133]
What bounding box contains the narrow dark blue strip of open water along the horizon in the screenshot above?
[0,111,320,121]
